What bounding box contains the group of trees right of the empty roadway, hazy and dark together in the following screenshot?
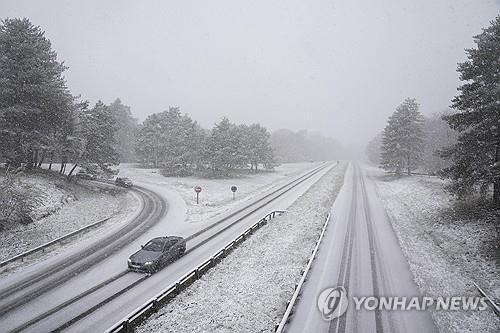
[367,16,500,206]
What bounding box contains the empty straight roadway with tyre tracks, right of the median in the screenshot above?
[285,164,436,333]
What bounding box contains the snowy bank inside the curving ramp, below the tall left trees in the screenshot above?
[0,174,139,269]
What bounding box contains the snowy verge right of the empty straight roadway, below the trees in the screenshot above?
[365,167,500,332]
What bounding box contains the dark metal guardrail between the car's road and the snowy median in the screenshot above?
[106,210,285,333]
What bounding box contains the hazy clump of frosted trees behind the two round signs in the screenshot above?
[136,107,274,176]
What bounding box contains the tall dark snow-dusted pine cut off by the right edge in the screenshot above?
[443,15,500,205]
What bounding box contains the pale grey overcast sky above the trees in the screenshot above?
[0,0,500,146]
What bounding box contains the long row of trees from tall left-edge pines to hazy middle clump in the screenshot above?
[0,18,274,178]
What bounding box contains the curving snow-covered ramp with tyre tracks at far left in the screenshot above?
[0,184,168,332]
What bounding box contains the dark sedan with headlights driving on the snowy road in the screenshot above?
[128,236,186,273]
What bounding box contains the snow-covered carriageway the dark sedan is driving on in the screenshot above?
[0,162,331,332]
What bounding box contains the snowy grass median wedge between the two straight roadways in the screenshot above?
[137,164,345,332]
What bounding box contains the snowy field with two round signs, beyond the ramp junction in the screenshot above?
[119,163,320,223]
